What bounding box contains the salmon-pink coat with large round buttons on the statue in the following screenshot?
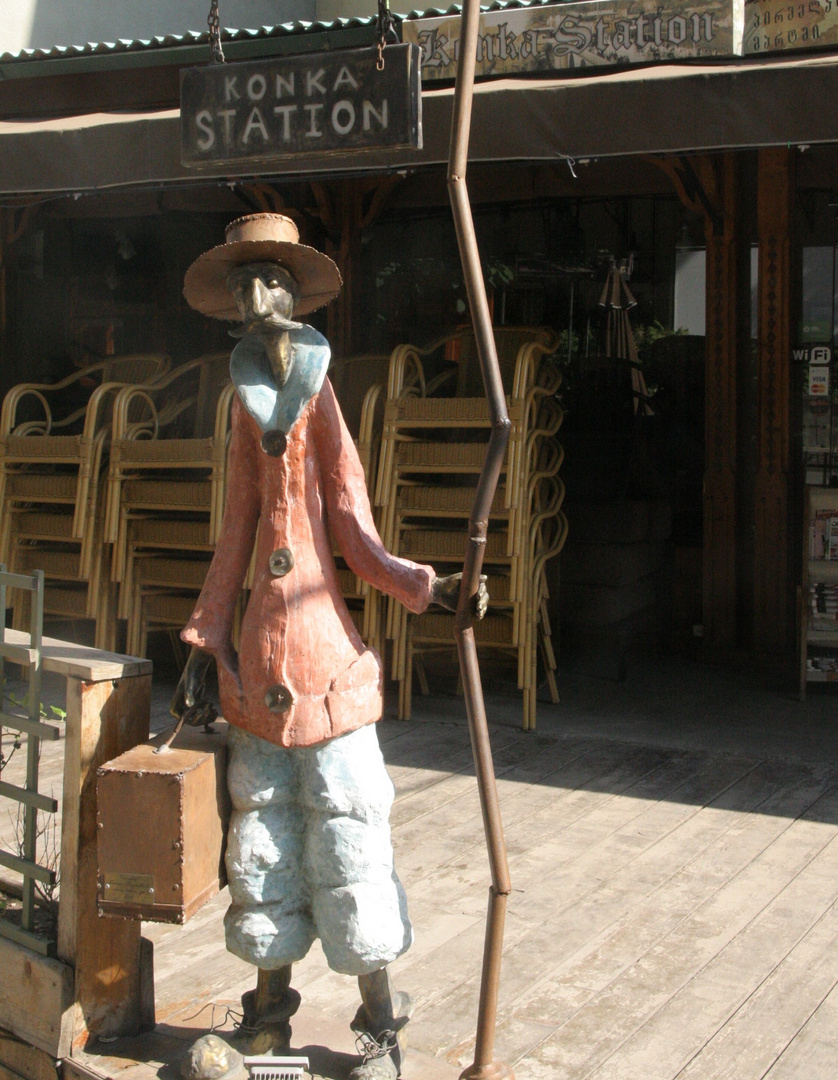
[180,379,434,746]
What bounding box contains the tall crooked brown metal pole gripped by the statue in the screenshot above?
[448,0,514,1080]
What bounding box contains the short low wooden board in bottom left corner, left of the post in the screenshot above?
[0,937,73,1059]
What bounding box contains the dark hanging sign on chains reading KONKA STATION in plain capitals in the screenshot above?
[180,44,422,166]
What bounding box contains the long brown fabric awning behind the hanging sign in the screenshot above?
[0,55,838,194]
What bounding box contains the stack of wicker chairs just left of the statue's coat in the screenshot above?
[105,352,234,656]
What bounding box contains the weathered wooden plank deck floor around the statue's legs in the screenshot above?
[0,669,838,1080]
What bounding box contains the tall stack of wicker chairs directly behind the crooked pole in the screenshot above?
[376,327,567,728]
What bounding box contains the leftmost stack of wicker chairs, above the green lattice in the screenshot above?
[0,354,170,648]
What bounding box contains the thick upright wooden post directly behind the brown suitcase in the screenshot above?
[58,675,151,1044]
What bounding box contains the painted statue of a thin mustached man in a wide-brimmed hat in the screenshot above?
[172,214,487,1080]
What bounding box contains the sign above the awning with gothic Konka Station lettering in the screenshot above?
[402,0,742,80]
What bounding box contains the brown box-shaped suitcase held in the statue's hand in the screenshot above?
[97,721,230,923]
